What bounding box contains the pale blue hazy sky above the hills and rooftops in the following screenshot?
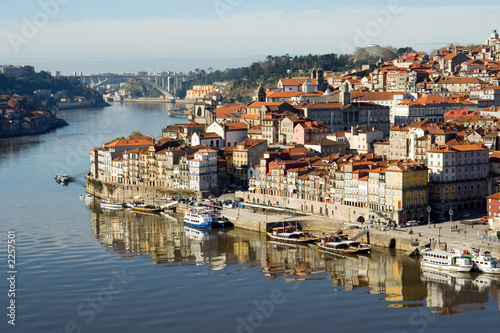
[0,0,500,74]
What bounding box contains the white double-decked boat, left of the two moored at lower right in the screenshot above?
[420,248,474,272]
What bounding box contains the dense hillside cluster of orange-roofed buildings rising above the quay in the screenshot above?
[89,31,500,232]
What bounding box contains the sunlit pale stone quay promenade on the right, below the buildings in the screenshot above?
[223,208,500,257]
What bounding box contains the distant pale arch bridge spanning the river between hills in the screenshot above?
[80,73,187,100]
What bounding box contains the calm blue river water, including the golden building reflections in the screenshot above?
[0,104,500,333]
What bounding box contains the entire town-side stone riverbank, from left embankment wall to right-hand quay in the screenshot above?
[87,177,500,257]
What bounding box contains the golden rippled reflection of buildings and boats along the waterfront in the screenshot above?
[92,211,500,315]
